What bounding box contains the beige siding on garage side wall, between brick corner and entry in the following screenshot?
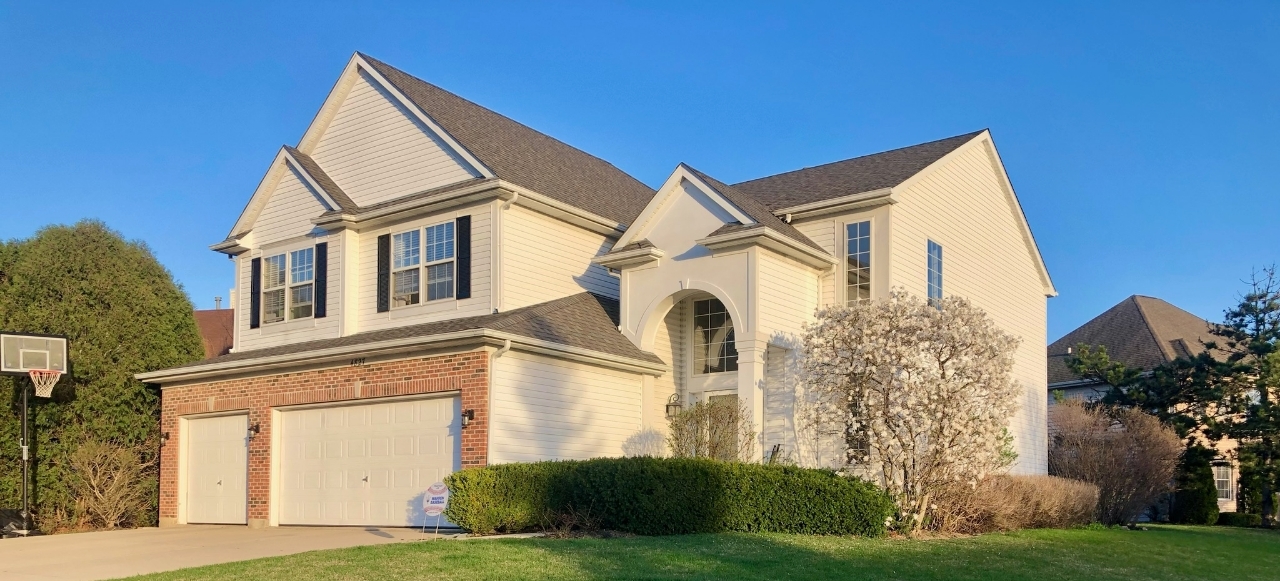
[489,351,641,463]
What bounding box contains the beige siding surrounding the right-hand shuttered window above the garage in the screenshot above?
[357,203,495,333]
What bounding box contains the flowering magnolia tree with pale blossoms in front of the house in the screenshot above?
[804,289,1021,532]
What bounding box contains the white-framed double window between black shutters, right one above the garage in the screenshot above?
[392,221,454,307]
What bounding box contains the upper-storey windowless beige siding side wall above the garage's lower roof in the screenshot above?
[502,206,618,311]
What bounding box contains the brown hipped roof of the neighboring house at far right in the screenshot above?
[1048,294,1217,385]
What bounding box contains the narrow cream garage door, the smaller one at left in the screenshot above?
[186,416,248,525]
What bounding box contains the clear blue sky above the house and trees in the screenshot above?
[0,1,1280,339]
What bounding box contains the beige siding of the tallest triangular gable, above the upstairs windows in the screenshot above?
[311,70,479,206]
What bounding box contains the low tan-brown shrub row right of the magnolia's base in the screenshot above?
[928,475,1098,535]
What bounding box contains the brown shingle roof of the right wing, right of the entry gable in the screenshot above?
[733,129,986,211]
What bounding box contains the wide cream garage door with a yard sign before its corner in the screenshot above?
[280,397,461,526]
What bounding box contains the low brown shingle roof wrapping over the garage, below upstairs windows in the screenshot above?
[165,293,664,371]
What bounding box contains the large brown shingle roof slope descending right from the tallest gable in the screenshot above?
[360,54,654,224]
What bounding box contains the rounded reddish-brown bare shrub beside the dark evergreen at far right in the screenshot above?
[1048,401,1183,525]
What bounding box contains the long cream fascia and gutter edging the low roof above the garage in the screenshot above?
[133,329,669,384]
